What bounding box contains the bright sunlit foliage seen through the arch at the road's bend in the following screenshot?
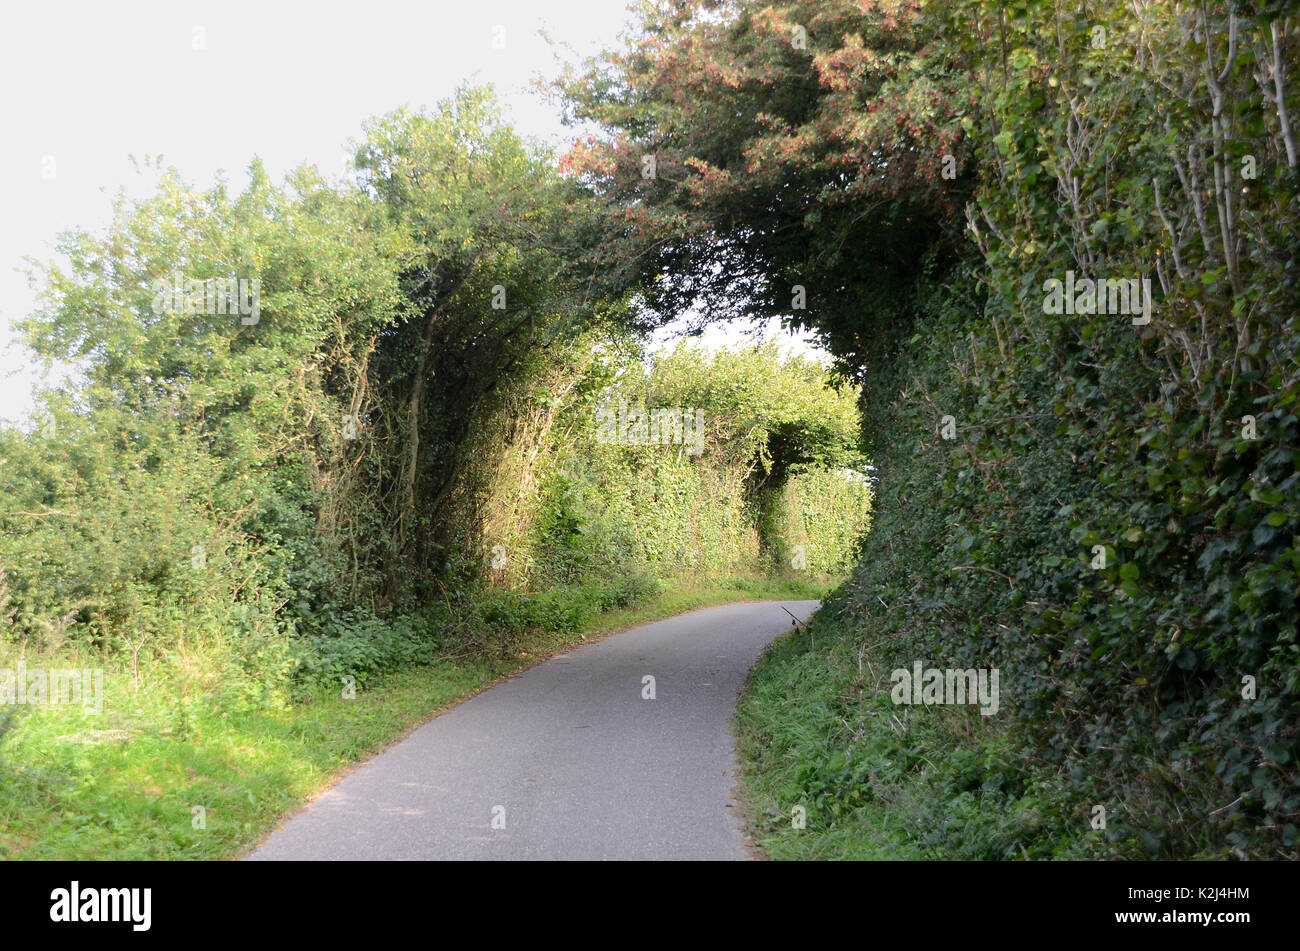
[519,343,870,587]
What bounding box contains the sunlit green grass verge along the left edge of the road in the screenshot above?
[0,578,823,859]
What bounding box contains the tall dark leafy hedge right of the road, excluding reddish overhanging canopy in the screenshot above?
[745,4,1300,859]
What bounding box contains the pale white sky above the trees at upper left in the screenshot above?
[0,0,821,420]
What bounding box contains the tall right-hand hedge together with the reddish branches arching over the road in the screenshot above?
[590,0,1300,857]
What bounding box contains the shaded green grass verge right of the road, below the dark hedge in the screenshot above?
[735,608,1086,860]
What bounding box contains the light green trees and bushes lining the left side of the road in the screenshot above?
[0,88,859,795]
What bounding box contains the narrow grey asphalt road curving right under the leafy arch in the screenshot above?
[250,602,818,860]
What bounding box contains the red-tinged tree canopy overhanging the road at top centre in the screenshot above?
[558,0,975,350]
